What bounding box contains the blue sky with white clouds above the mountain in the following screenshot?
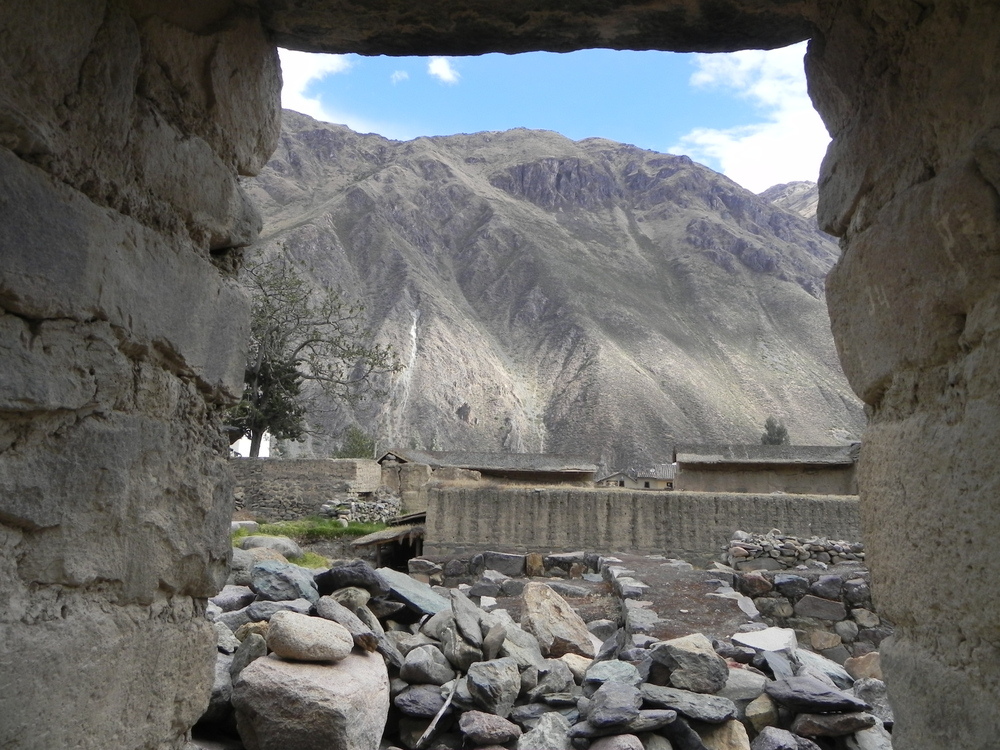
[281,44,829,192]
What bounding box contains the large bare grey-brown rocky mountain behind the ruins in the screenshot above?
[250,112,863,467]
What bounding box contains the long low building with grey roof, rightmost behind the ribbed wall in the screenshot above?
[674,443,860,495]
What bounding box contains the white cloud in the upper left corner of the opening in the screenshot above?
[278,49,414,140]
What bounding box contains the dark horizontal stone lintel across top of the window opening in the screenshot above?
[260,0,815,55]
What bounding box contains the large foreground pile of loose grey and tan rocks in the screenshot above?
[204,536,892,750]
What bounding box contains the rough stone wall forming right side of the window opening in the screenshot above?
[806,0,1000,750]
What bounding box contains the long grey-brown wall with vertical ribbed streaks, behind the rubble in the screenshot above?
[424,487,861,563]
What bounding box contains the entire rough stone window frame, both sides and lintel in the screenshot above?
[0,0,1000,748]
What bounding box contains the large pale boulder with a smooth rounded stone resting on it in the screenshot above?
[233,653,389,750]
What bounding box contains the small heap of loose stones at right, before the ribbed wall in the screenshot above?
[722,529,865,570]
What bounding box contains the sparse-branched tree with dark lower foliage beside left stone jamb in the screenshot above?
[227,259,399,456]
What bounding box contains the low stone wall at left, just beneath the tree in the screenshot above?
[230,458,382,521]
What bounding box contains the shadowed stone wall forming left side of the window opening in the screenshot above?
[0,0,279,750]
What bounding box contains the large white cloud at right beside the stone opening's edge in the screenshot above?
[671,43,830,192]
